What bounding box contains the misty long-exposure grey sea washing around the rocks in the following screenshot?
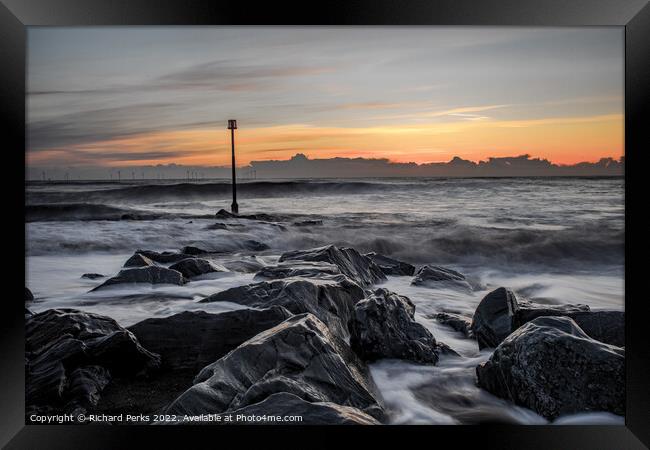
[25,177,625,425]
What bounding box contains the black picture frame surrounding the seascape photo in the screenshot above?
[0,0,650,449]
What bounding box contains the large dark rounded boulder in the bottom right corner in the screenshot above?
[476,316,625,419]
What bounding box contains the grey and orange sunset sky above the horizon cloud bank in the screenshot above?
[27,27,624,168]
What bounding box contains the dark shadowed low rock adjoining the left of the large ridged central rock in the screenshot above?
[129,306,292,373]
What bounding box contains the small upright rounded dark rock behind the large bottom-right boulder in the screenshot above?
[472,287,519,349]
